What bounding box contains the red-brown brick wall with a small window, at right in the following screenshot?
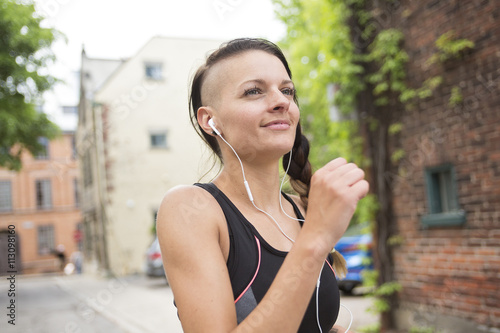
[394,0,500,331]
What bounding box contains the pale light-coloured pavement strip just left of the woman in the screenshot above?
[53,274,182,333]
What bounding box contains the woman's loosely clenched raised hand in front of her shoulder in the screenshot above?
[304,158,369,251]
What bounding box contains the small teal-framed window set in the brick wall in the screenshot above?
[421,164,465,226]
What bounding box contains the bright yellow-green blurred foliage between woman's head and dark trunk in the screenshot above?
[273,0,376,223]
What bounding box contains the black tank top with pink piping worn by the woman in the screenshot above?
[195,183,340,333]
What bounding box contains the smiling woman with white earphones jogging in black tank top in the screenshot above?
[157,39,368,333]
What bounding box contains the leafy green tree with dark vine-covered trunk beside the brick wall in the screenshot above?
[274,0,408,331]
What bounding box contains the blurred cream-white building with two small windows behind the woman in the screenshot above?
[78,37,221,275]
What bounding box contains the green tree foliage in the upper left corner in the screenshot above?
[0,0,59,170]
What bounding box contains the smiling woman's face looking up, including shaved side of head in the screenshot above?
[203,51,300,160]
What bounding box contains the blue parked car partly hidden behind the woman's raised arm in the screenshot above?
[335,228,373,294]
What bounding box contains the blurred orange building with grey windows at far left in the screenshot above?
[0,132,83,274]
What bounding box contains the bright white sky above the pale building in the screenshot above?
[34,0,286,130]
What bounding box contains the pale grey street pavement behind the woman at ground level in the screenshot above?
[0,274,376,333]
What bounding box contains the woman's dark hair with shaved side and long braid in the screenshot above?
[189,38,312,207]
